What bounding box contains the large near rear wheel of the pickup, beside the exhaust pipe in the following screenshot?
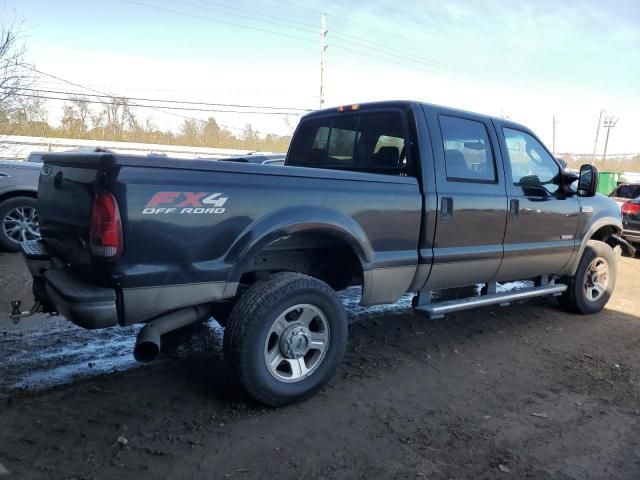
[224,273,347,407]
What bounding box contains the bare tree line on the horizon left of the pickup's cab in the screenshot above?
[0,22,291,152]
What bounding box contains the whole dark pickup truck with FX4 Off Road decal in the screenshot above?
[12,101,633,406]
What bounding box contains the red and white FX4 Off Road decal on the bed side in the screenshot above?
[142,192,229,215]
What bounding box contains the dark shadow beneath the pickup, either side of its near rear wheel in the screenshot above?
[156,287,624,405]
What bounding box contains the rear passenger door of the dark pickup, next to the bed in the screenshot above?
[424,107,507,290]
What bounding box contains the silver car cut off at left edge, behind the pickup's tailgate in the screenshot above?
[0,160,42,252]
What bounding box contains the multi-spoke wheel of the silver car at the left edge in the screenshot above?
[0,197,40,252]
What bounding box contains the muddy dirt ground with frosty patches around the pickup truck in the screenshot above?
[0,254,640,480]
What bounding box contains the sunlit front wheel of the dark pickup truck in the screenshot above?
[560,240,618,314]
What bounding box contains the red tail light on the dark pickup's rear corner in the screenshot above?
[91,192,124,259]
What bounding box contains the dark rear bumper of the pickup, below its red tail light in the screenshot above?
[22,241,118,330]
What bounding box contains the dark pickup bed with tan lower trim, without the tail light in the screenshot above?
[39,153,422,323]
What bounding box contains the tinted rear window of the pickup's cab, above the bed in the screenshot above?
[286,110,409,175]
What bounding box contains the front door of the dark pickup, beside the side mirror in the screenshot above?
[496,122,580,281]
